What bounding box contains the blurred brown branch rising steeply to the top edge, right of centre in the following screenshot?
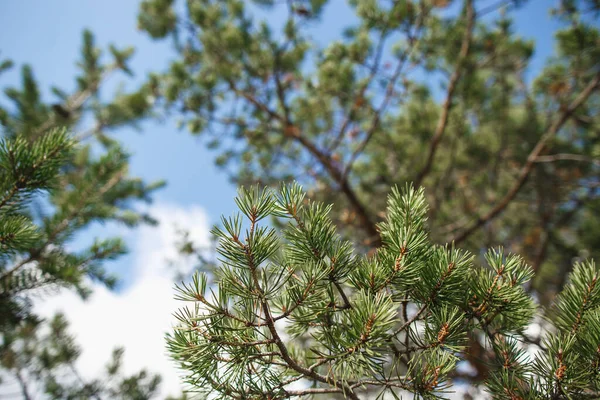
[414,0,476,188]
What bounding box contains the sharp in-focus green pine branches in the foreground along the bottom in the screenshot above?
[167,184,600,399]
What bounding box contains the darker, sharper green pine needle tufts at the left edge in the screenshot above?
[0,130,73,328]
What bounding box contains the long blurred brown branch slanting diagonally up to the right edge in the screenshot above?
[452,73,600,243]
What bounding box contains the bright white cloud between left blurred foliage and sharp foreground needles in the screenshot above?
[36,204,209,395]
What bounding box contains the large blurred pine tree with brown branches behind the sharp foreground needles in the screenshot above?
[138,0,600,396]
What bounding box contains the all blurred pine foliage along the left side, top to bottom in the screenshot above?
[0,32,168,399]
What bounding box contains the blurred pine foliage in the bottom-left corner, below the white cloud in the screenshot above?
[0,314,160,400]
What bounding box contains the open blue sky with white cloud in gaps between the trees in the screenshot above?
[0,0,572,396]
